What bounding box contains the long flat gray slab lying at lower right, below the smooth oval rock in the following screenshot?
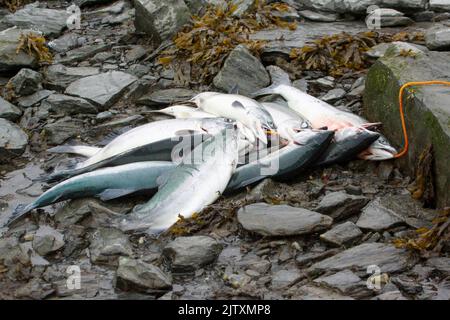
[308,243,414,275]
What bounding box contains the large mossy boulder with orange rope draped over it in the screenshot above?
[364,49,450,206]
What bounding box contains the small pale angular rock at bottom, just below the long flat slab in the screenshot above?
[314,270,373,299]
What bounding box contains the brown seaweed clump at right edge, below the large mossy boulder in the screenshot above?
[393,208,450,256]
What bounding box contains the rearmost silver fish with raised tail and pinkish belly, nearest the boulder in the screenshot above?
[254,66,396,160]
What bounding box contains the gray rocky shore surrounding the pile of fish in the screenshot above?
[0,0,450,300]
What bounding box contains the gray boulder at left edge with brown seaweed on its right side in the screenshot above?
[0,28,37,72]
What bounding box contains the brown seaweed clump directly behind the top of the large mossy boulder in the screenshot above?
[290,31,423,77]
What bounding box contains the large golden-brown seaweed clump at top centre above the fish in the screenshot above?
[159,1,296,83]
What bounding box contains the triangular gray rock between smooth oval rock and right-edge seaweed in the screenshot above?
[356,198,403,231]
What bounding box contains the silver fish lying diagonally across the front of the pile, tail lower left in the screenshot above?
[120,129,238,235]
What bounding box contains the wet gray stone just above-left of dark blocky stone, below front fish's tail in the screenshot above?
[89,228,133,265]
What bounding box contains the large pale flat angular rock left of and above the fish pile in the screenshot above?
[65,71,137,108]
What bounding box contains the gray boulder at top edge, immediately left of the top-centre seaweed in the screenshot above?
[134,0,190,42]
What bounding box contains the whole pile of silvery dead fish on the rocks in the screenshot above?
[5,66,396,235]
